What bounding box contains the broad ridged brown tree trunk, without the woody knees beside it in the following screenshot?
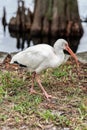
[31,0,83,36]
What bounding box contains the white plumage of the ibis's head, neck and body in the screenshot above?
[10,39,67,73]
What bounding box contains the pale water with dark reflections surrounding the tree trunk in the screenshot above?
[0,0,87,53]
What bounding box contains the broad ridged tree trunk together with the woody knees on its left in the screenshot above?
[9,0,83,37]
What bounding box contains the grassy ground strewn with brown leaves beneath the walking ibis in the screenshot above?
[0,56,87,130]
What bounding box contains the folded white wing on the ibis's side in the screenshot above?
[11,44,53,71]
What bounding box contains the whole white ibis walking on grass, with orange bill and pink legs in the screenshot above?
[10,39,78,100]
